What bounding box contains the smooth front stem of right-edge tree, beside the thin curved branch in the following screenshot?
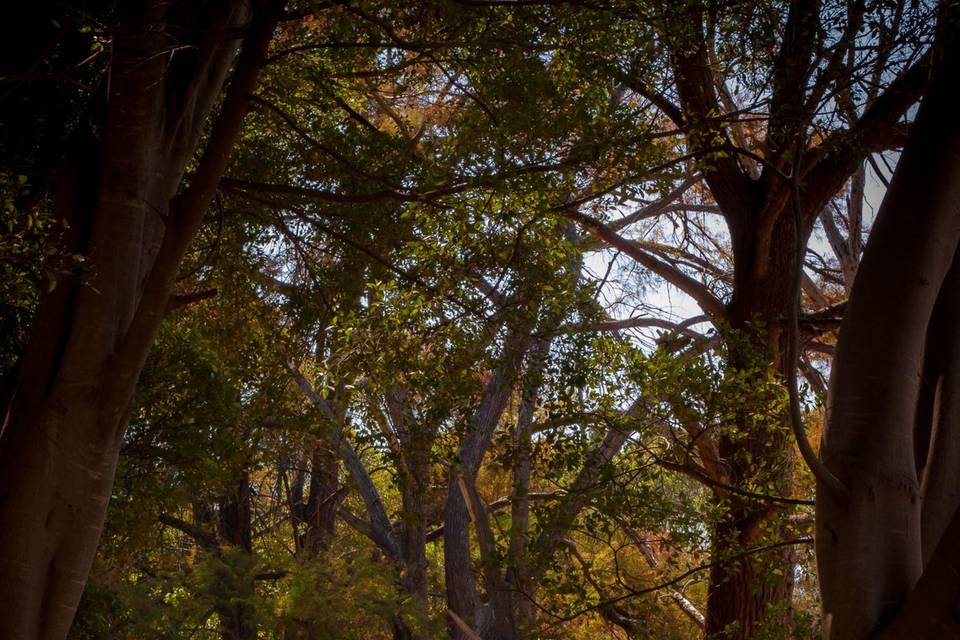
[817,18,960,639]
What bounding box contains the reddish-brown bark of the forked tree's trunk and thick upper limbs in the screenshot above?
[648,0,929,639]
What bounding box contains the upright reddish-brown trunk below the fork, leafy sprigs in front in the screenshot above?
[706,211,809,640]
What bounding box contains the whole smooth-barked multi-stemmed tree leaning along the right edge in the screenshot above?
[817,3,960,638]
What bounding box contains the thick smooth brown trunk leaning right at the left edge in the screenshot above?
[0,2,275,640]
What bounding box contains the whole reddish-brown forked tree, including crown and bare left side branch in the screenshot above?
[552,2,929,638]
